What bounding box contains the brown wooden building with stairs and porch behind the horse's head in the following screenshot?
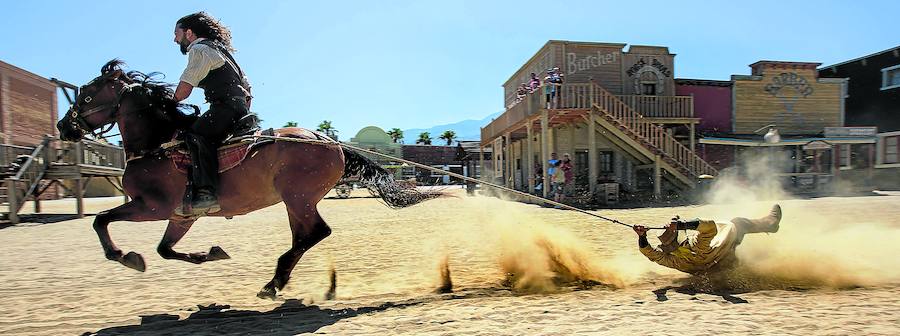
[0,61,125,223]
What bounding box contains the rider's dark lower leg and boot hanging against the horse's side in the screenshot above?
[185,133,220,215]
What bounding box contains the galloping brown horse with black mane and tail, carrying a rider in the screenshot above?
[57,60,437,298]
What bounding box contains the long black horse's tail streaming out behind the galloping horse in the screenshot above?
[341,147,443,208]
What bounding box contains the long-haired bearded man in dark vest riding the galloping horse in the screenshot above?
[175,12,259,216]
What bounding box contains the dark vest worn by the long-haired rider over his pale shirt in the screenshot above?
[197,40,250,103]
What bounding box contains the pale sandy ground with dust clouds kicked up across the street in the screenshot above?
[0,191,900,335]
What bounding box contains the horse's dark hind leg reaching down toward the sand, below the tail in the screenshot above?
[257,199,331,298]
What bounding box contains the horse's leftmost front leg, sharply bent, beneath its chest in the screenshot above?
[94,199,167,272]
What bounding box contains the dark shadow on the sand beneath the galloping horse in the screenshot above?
[83,299,422,335]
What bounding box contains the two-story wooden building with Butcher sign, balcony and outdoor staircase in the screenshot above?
[481,40,716,201]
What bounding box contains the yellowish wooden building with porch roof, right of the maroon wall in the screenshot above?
[696,61,876,192]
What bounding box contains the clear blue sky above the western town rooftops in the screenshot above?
[0,0,900,139]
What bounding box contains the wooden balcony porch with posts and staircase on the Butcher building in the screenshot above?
[481,83,716,200]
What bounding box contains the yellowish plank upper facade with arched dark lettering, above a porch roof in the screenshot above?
[733,68,842,134]
